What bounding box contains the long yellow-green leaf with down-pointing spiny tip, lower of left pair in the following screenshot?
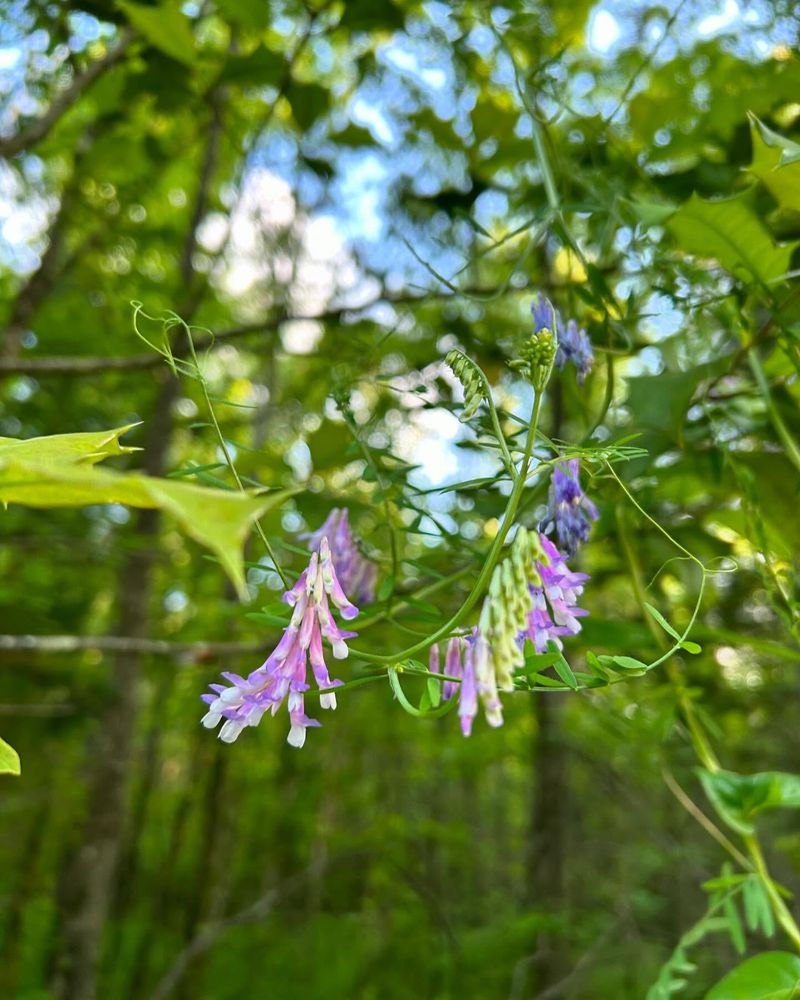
[0,456,297,595]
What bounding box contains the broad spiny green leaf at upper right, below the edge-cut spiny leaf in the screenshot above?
[667,191,797,282]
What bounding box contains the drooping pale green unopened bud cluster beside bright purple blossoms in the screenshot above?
[478,527,547,696]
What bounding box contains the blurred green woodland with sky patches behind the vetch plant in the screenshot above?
[0,0,800,1000]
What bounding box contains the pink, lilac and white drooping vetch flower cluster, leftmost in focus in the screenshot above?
[202,536,358,747]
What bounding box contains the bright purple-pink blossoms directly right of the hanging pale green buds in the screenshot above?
[520,535,589,653]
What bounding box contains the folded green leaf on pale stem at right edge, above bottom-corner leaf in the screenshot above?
[698,768,800,834]
